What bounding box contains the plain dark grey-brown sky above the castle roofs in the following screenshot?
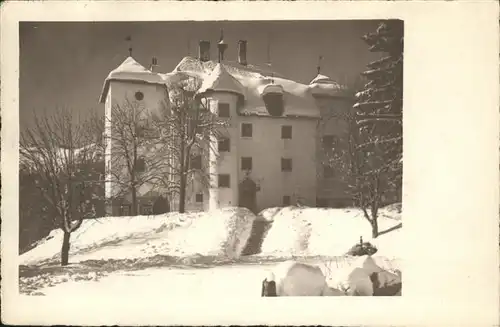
[19,20,377,130]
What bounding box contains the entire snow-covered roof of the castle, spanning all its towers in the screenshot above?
[97,57,344,118]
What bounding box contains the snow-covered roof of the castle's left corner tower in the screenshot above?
[99,57,165,103]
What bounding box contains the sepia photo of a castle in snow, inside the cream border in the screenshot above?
[19,20,406,298]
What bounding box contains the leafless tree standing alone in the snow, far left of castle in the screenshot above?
[20,109,102,266]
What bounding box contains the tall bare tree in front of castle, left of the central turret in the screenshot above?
[155,79,227,213]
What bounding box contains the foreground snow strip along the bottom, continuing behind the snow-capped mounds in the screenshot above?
[27,257,395,298]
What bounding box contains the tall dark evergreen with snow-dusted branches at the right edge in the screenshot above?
[354,20,404,164]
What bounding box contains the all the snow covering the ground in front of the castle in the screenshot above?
[20,206,402,297]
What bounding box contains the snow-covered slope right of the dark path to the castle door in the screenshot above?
[259,207,400,258]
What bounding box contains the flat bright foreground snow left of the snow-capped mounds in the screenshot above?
[33,265,268,298]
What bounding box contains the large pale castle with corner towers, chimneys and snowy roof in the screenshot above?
[100,39,354,215]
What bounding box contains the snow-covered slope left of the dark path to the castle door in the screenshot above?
[20,208,255,265]
